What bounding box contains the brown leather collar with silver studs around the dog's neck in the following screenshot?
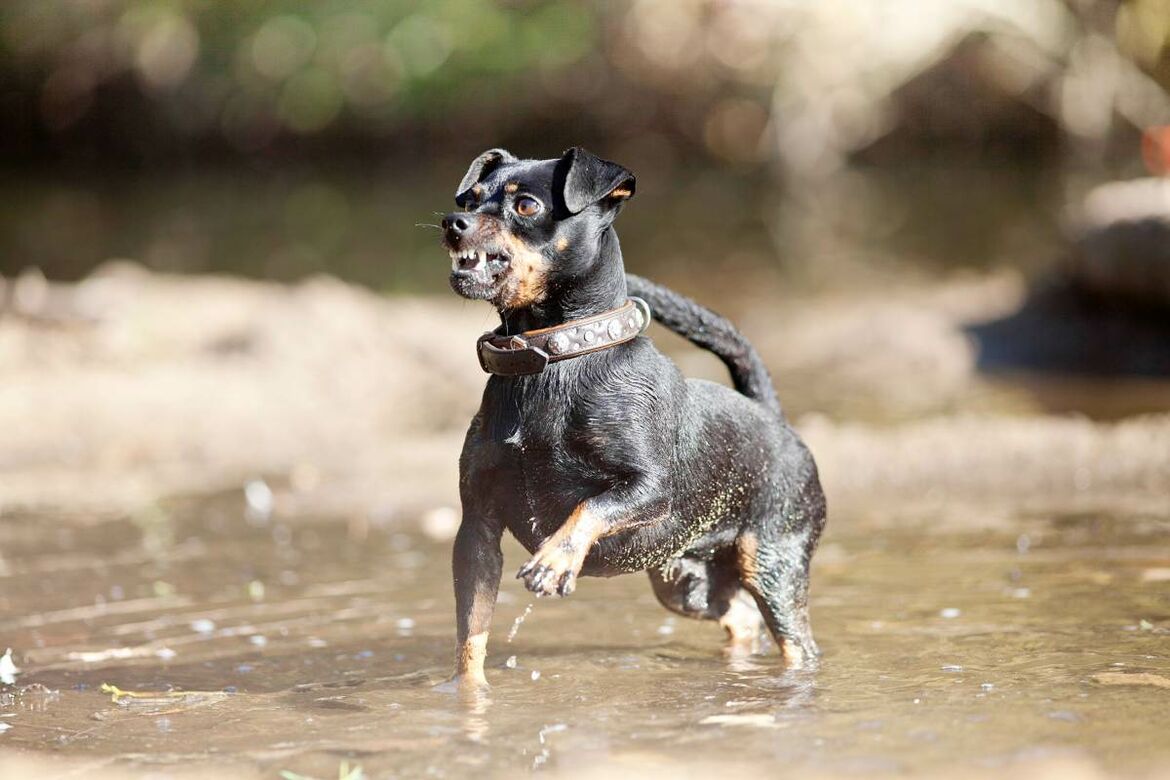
[475,298,651,377]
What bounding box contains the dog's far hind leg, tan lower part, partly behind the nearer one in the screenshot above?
[649,551,764,653]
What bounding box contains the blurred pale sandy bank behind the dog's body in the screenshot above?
[0,264,1170,517]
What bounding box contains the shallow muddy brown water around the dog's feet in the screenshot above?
[0,495,1170,778]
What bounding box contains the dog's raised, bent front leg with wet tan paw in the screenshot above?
[516,478,669,596]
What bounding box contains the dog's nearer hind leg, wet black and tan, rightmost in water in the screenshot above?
[736,484,825,669]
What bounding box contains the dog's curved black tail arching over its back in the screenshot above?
[626,274,783,415]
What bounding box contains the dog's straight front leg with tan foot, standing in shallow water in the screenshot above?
[452,509,504,686]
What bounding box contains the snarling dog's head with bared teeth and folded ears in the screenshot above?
[442,147,634,311]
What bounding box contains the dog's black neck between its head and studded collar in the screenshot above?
[500,227,627,333]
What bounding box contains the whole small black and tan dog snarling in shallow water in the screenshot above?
[442,149,825,685]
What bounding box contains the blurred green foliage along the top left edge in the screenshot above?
[0,0,599,143]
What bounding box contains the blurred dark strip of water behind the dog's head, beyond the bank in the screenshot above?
[0,160,1065,294]
